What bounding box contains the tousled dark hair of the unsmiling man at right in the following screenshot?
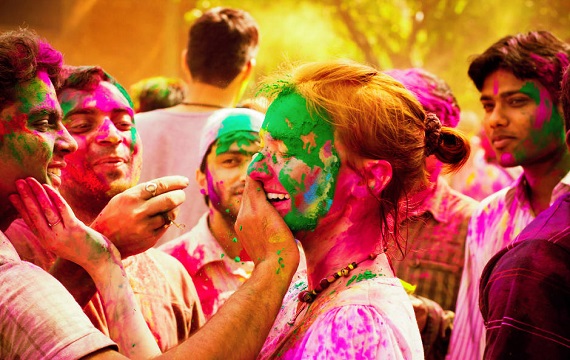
[468,31,570,104]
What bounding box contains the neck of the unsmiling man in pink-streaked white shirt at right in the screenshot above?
[523,151,570,215]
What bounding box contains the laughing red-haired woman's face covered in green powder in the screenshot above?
[248,93,340,231]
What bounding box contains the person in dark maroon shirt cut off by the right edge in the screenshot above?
[479,62,570,359]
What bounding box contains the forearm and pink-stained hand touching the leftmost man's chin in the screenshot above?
[10,178,160,359]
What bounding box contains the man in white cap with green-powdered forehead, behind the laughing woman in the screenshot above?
[160,108,264,319]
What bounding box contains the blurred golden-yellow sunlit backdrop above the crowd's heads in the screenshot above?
[0,0,570,129]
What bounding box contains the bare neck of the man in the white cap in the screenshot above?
[208,208,247,261]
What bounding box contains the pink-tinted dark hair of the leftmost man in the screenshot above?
[0,29,63,109]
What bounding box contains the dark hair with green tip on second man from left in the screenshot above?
[56,65,133,108]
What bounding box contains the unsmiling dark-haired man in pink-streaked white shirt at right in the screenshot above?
[449,31,570,359]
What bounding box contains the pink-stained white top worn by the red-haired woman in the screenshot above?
[258,256,423,360]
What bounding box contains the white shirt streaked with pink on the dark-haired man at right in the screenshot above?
[447,172,570,360]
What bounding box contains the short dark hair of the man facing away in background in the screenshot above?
[186,7,259,88]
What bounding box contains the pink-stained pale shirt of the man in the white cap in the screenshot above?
[159,213,254,319]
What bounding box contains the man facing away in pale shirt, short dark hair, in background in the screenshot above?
[135,8,259,243]
